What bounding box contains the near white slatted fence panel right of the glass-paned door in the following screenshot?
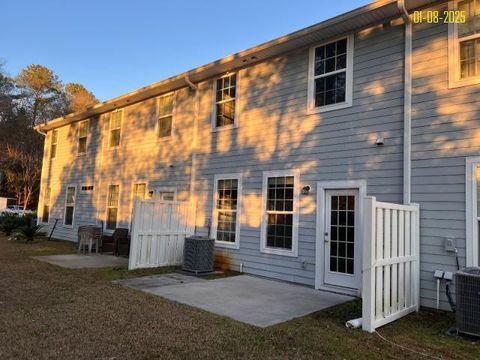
[362,197,420,332]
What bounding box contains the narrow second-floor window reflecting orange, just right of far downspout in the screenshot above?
[214,74,237,128]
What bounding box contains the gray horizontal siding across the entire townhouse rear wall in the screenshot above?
[36,0,480,309]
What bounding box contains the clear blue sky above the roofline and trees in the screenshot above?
[0,0,370,100]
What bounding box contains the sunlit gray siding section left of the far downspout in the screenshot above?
[39,89,193,241]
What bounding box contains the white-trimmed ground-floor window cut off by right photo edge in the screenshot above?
[465,156,480,266]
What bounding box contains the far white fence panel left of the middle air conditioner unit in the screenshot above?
[128,199,195,270]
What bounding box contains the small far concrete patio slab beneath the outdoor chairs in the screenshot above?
[32,254,128,269]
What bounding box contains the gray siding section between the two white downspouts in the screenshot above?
[193,26,403,286]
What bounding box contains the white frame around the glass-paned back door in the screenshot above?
[315,180,367,289]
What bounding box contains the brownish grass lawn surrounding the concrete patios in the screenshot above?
[0,235,480,359]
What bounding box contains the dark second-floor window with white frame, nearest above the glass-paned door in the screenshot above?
[309,37,353,110]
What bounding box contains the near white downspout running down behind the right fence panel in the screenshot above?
[397,0,413,204]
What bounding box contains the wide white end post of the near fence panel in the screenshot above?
[362,196,376,332]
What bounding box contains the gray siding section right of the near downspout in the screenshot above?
[412,0,480,309]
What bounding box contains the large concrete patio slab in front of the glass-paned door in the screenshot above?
[116,275,353,327]
